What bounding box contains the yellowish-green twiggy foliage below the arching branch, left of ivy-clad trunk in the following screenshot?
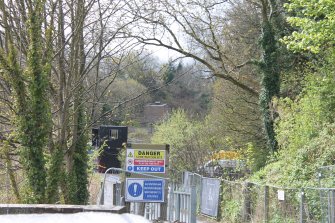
[203,79,265,155]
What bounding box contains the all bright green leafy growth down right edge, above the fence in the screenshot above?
[252,0,335,190]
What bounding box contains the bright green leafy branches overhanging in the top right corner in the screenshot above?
[283,0,335,53]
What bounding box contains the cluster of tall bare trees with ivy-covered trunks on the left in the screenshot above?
[0,0,148,204]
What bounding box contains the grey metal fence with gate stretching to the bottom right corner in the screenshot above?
[97,169,335,223]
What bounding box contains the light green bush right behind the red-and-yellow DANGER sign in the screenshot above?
[151,110,209,179]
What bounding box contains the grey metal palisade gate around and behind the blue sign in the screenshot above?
[97,168,200,223]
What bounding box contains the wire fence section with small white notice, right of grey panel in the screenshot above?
[220,180,335,223]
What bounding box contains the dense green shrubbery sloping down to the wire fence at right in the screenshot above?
[255,66,335,187]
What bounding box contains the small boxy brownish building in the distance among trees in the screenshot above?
[143,101,171,125]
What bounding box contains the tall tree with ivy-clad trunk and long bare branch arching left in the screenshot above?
[122,0,288,155]
